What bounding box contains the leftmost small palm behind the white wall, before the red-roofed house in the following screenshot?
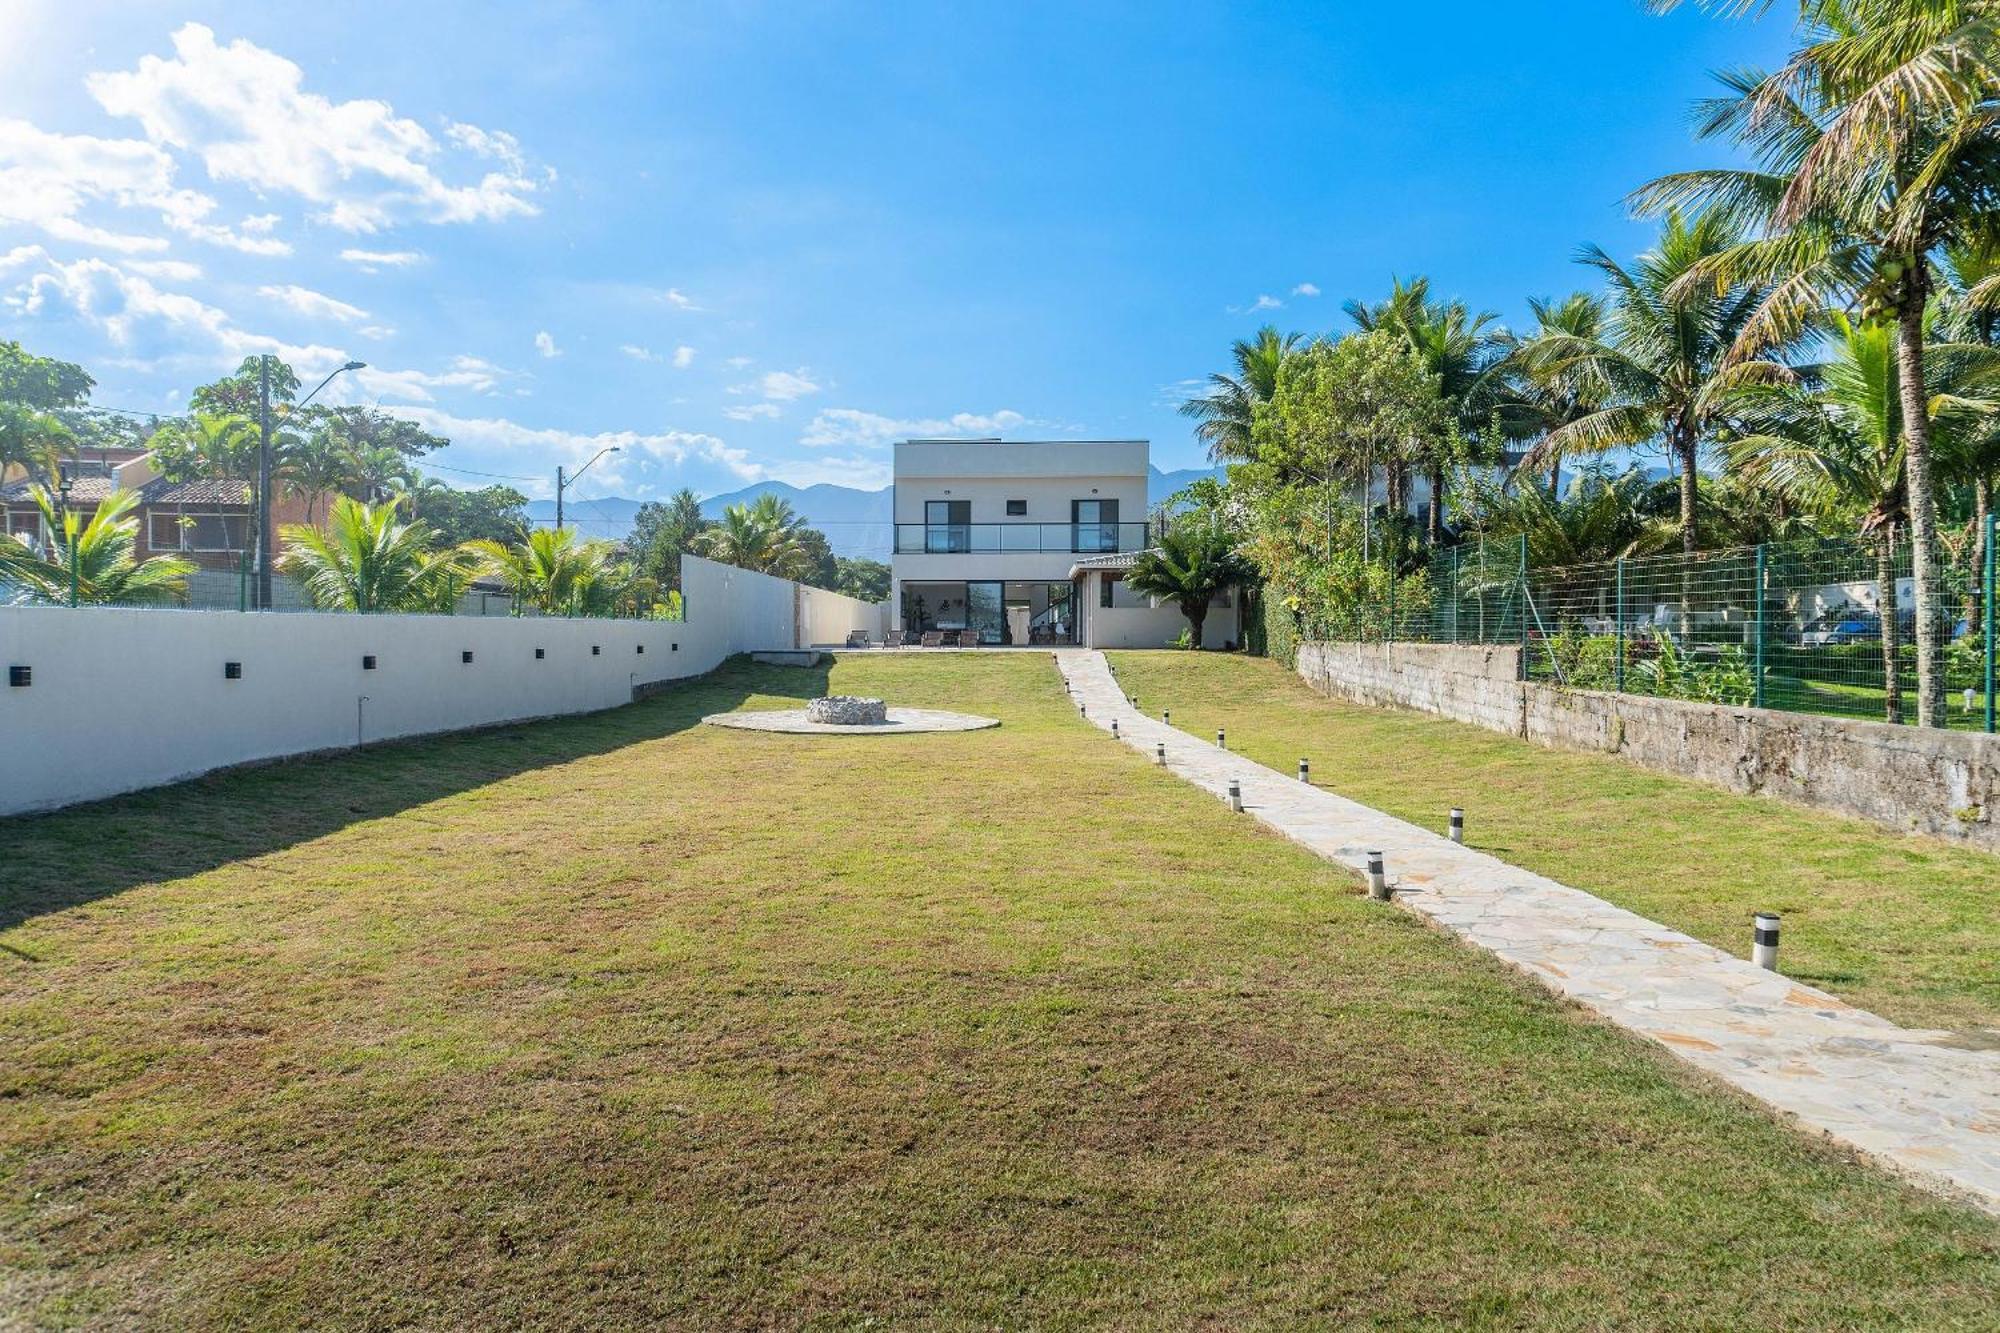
[0,486,196,606]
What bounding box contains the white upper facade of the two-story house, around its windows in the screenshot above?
[888,440,1148,628]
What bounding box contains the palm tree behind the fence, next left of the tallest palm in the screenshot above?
[1522,214,1790,554]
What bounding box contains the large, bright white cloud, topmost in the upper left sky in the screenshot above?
[86,24,540,232]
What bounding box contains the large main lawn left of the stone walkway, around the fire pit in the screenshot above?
[0,654,2000,1329]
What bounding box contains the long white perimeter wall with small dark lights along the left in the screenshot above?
[0,556,880,815]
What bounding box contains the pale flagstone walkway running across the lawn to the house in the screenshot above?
[1056,652,2000,1213]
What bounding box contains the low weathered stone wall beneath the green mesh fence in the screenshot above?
[1298,642,2000,851]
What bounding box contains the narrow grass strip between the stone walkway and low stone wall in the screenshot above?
[1112,652,2000,1043]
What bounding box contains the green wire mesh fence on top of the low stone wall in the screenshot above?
[1312,520,1996,731]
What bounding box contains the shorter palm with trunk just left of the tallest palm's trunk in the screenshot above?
[1728,314,1992,723]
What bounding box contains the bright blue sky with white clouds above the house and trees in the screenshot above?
[0,0,1786,496]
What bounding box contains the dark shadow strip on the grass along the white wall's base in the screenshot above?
[0,656,830,932]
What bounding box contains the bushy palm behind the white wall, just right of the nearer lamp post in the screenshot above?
[278,496,472,612]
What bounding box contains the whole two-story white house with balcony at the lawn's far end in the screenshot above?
[890,440,1236,648]
